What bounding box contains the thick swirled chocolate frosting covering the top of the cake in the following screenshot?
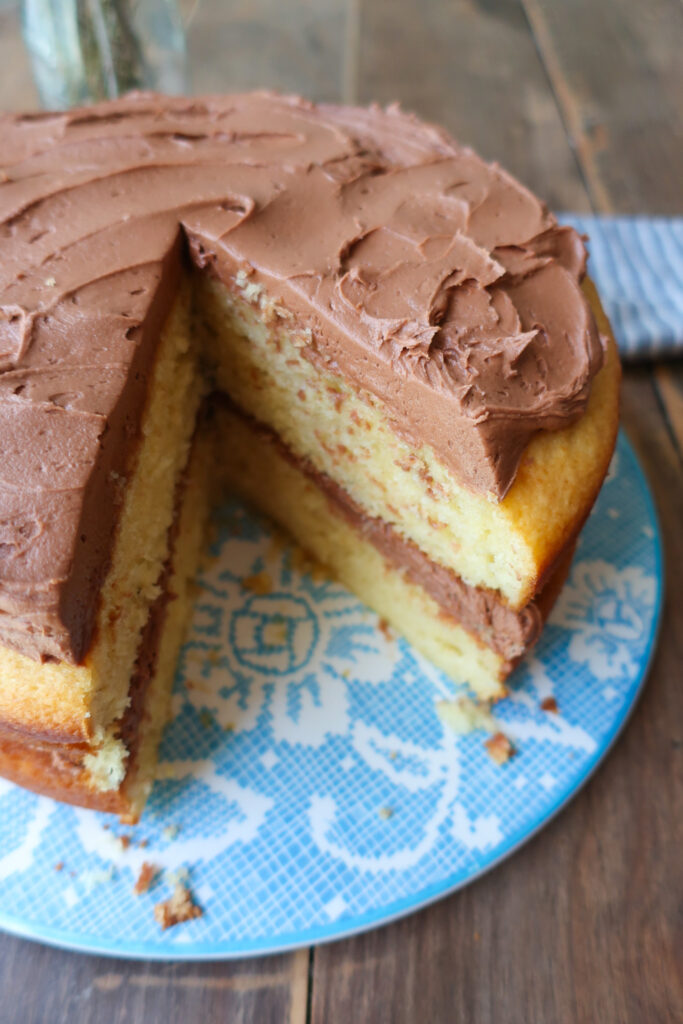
[0,93,603,662]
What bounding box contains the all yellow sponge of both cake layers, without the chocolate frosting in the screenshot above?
[0,275,620,806]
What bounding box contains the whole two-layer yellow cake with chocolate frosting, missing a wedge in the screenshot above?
[0,93,618,818]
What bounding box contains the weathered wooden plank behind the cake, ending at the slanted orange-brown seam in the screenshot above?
[356,0,589,211]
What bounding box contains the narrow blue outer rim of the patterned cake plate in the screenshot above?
[0,428,665,963]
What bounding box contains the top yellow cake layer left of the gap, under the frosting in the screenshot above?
[0,282,202,749]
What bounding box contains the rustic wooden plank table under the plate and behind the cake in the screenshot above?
[0,0,683,1024]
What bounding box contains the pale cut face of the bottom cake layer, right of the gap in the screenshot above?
[216,410,507,699]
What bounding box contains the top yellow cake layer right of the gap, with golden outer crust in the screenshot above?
[196,275,620,609]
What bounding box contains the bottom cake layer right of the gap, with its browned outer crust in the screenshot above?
[214,404,573,700]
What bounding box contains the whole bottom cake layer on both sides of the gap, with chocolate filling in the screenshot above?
[0,400,573,822]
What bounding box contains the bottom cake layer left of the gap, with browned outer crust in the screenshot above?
[0,438,209,823]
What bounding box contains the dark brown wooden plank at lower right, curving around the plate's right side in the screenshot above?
[311,371,683,1024]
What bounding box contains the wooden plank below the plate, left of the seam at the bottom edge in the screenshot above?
[0,933,308,1024]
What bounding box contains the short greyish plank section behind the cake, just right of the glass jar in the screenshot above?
[187,0,346,101]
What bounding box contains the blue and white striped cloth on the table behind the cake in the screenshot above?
[558,213,683,359]
